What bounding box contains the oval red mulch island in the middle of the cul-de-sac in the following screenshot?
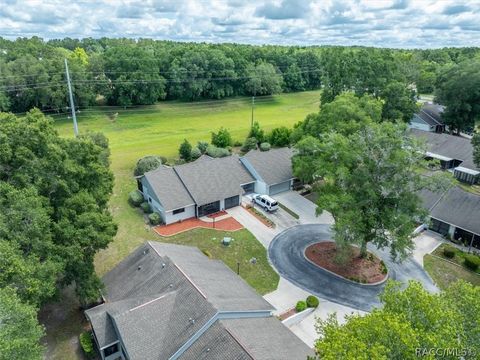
[305,241,387,284]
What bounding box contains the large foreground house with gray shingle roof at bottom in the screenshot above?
[85,242,312,360]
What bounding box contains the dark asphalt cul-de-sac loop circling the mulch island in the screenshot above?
[268,224,438,311]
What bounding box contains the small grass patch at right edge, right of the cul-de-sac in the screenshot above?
[423,254,480,289]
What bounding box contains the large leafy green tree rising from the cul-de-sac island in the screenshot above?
[293,122,446,258]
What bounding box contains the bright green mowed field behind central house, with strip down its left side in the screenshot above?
[55,91,320,275]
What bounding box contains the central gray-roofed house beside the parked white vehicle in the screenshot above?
[137,148,293,224]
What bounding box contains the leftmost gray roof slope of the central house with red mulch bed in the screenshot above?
[145,166,195,211]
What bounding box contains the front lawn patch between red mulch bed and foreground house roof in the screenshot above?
[157,229,279,295]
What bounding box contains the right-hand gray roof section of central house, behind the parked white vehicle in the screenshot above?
[244,147,293,185]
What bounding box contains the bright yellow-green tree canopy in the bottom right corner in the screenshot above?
[315,281,480,360]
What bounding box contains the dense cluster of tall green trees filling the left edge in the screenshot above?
[0,110,117,359]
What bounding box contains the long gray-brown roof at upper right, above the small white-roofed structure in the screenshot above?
[410,129,480,170]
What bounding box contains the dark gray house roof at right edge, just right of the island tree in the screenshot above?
[420,186,480,235]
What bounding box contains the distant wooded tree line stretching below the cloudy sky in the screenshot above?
[0,37,479,112]
